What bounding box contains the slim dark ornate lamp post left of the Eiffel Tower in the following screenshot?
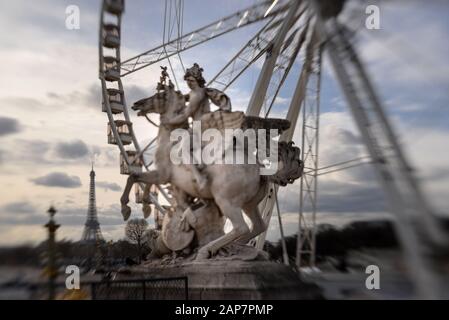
[45,206,60,300]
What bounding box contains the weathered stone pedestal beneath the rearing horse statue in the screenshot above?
[128,260,322,300]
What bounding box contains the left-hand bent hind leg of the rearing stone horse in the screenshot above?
[196,199,249,260]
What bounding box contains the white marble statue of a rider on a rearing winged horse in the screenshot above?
[121,64,303,259]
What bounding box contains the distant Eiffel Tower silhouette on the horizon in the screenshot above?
[81,164,104,242]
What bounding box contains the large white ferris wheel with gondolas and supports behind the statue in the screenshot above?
[99,0,447,297]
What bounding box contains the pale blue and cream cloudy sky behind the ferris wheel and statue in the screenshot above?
[0,0,449,245]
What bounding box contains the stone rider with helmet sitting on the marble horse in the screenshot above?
[164,63,231,190]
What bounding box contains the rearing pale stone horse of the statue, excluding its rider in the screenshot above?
[121,85,303,259]
